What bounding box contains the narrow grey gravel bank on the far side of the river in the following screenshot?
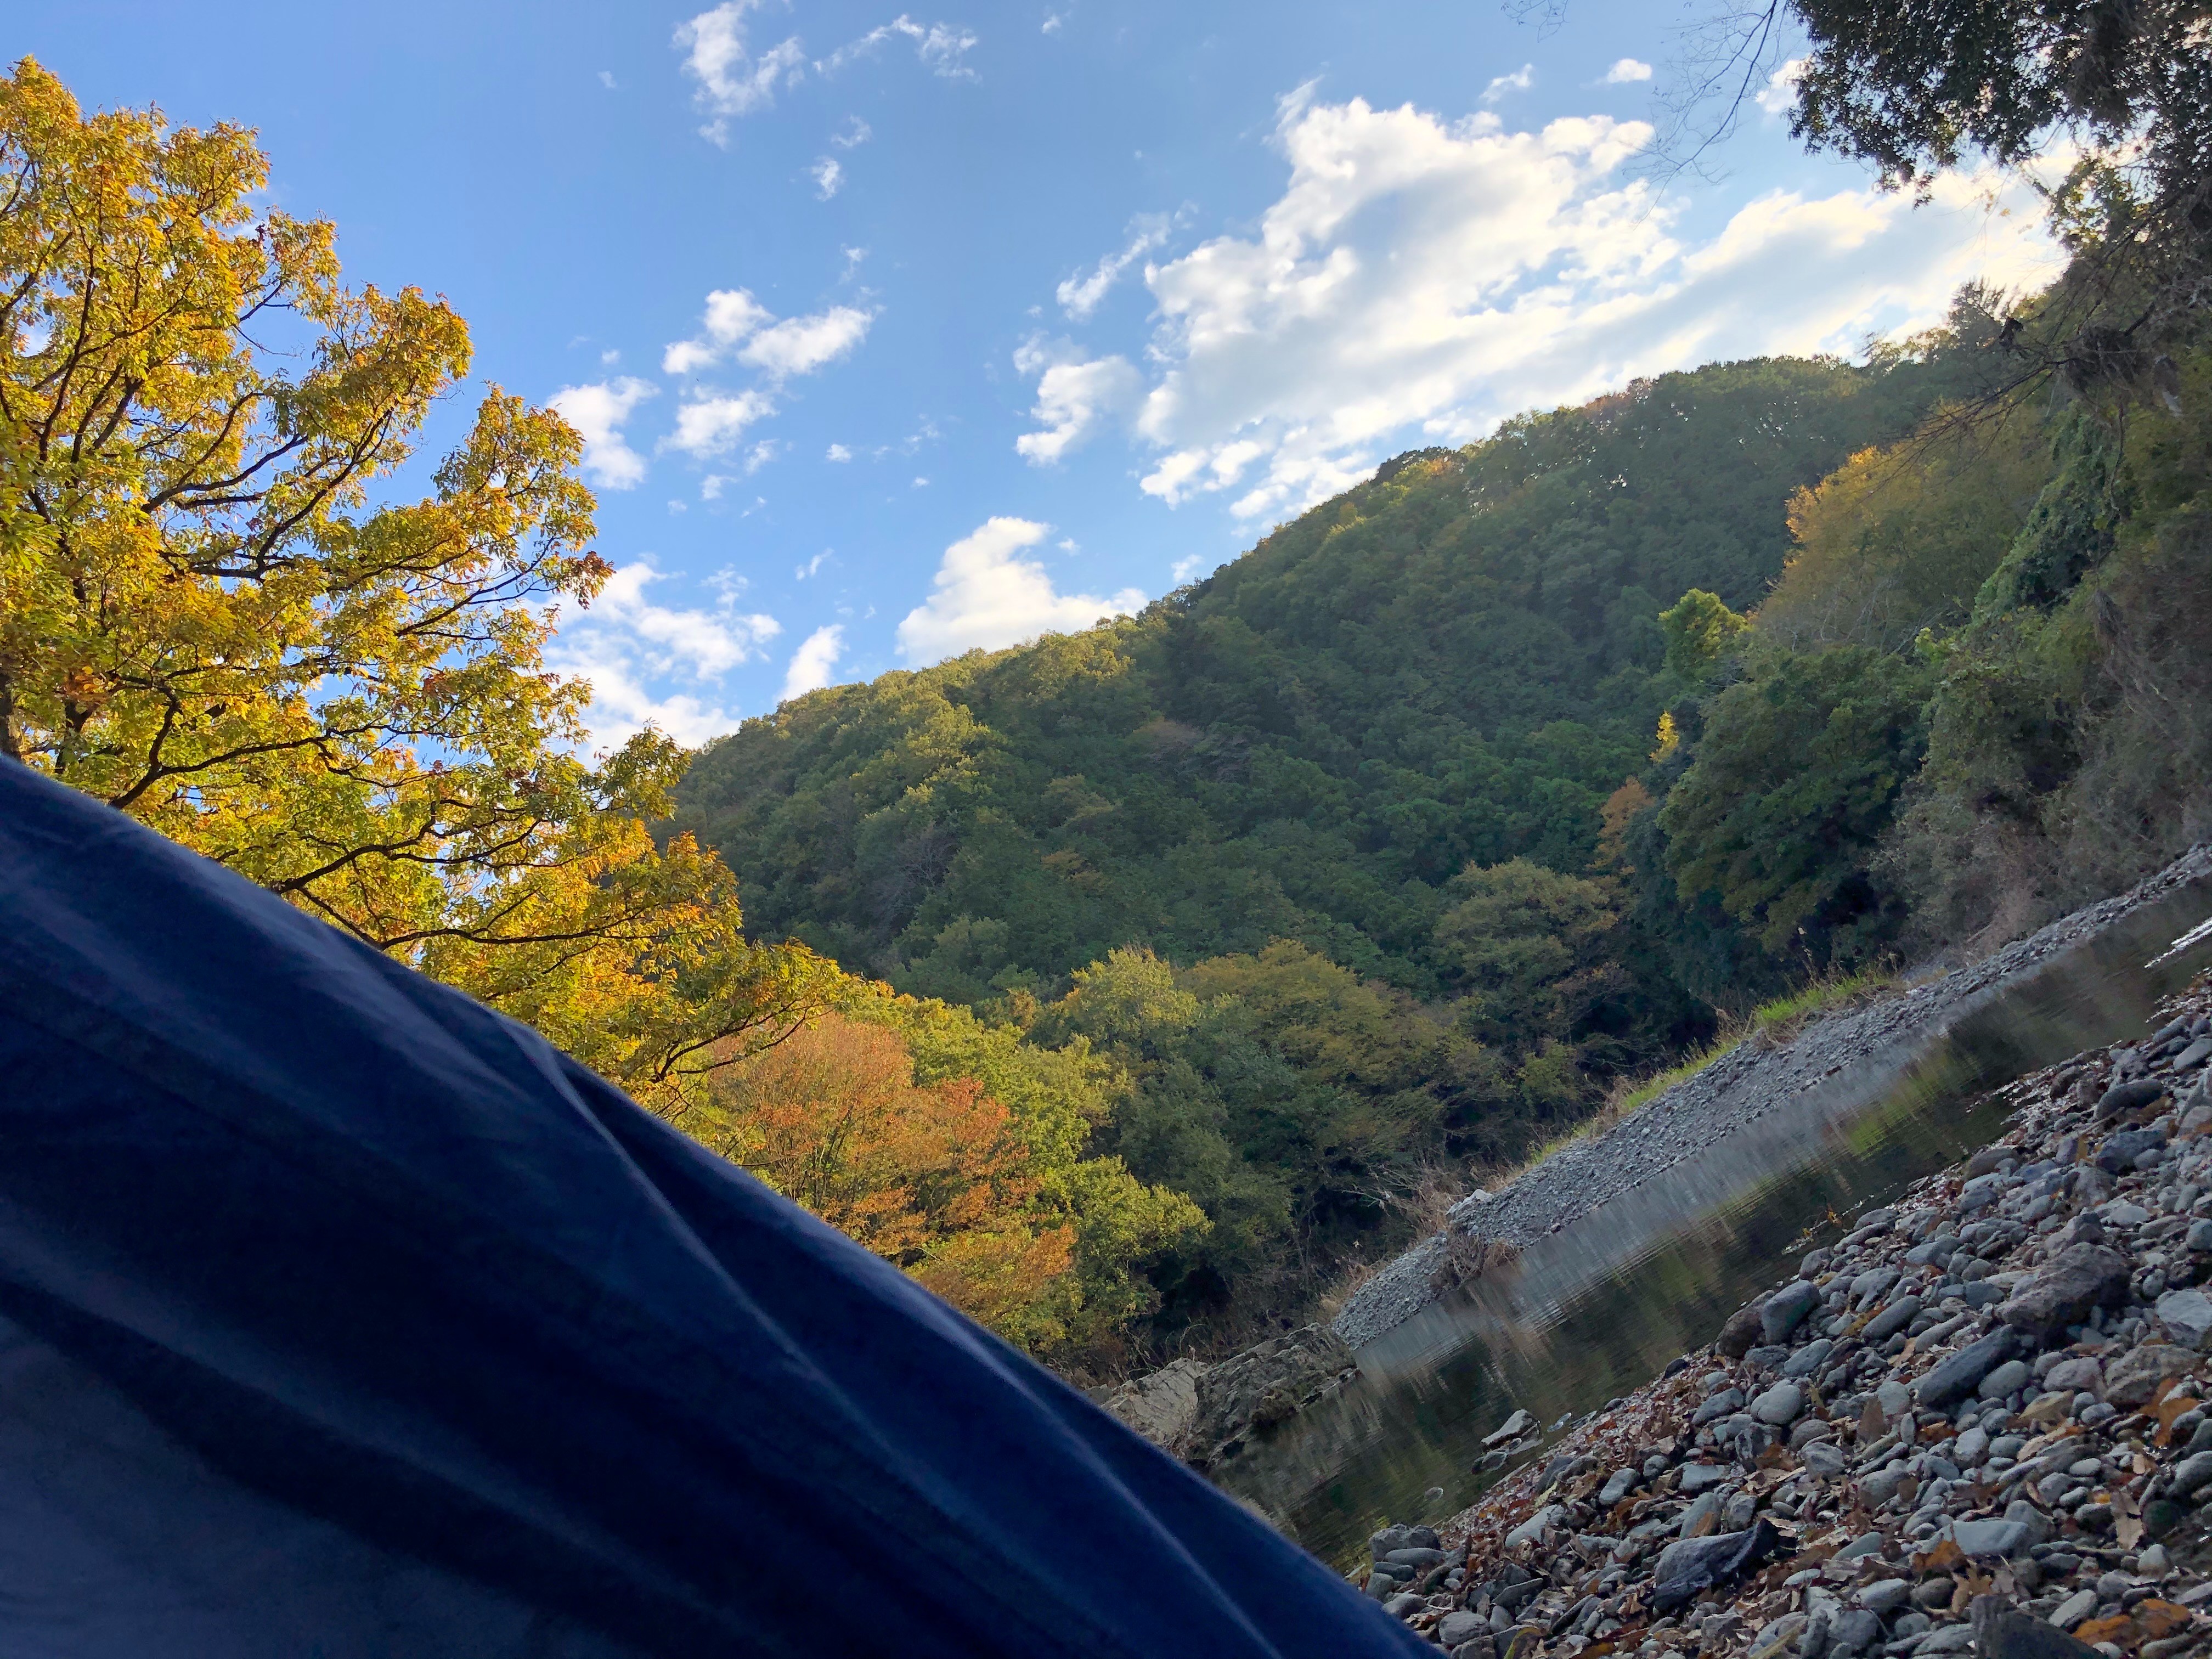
[1334,847,2212,1347]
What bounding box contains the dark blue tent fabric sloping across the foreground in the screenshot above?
[0,763,1434,1659]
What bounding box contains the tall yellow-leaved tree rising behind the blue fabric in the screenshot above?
[0,60,836,1108]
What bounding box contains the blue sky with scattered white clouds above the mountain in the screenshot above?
[26,0,2049,741]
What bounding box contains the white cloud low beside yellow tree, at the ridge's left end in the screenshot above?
[546,562,783,746]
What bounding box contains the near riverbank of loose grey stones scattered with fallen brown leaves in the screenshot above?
[1361,982,2212,1659]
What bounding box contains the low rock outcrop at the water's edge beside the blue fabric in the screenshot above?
[1099,1325,1358,1469]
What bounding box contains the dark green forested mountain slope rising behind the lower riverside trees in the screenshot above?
[681,360,1955,1002]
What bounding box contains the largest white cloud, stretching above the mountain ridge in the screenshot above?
[1115,88,2055,517]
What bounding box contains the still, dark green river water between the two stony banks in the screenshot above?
[1215,881,2212,1566]
